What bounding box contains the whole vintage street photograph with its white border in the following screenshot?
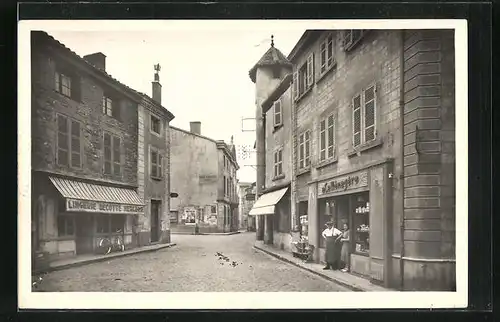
[18,19,468,309]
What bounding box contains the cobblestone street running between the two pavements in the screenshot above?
[36,233,348,292]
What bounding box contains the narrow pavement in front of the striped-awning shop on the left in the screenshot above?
[34,243,176,274]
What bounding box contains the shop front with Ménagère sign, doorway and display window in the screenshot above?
[309,163,392,284]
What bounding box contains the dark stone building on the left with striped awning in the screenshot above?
[31,31,144,266]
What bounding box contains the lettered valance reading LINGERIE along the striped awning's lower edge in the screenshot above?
[66,199,144,214]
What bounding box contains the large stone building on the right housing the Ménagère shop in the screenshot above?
[250,30,455,290]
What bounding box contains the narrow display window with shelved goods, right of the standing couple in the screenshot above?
[351,193,370,255]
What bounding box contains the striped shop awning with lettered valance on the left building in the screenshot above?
[49,177,144,214]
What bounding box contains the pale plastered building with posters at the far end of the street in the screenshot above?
[170,122,239,232]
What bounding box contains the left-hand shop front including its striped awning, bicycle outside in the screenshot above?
[34,176,144,260]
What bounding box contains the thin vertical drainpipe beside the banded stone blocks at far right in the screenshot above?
[399,30,405,291]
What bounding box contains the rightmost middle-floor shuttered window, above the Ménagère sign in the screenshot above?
[351,83,378,149]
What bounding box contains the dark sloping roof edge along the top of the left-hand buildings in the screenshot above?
[31,30,174,121]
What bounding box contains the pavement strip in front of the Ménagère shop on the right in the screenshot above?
[253,243,392,292]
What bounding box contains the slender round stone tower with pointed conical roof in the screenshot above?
[248,36,292,240]
